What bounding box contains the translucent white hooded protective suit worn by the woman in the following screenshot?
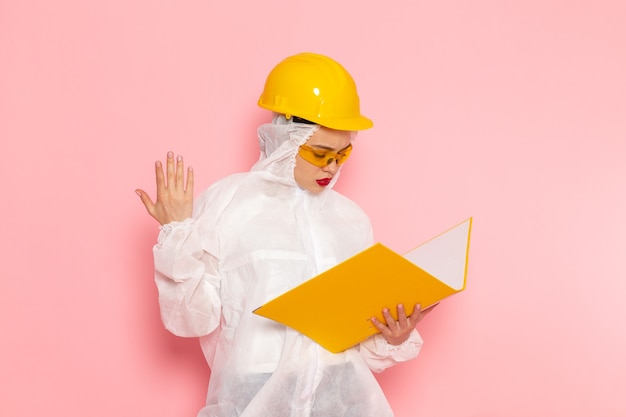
[154,115,422,417]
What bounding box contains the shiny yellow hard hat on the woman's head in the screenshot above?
[258,52,374,130]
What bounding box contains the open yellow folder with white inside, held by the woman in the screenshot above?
[254,218,472,353]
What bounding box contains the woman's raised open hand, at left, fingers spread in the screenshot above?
[135,152,193,225]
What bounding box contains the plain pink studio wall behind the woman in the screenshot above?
[0,0,626,417]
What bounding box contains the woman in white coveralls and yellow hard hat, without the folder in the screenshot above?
[137,53,425,417]
